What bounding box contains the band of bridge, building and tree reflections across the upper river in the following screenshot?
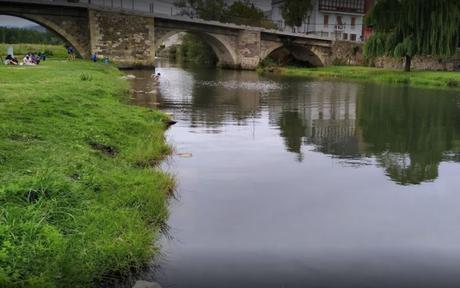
[130,67,460,185]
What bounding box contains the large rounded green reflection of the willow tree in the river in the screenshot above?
[359,86,459,185]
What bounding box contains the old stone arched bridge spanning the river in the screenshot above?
[0,0,332,69]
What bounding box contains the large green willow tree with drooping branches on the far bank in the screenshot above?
[364,0,460,71]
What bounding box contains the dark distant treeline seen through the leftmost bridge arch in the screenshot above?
[0,27,64,45]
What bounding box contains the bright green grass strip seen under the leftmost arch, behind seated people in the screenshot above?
[0,43,67,60]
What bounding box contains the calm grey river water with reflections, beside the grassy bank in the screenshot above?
[127,65,460,288]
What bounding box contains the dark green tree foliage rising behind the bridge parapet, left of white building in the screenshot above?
[174,0,276,29]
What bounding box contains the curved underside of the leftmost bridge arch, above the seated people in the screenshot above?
[0,11,89,57]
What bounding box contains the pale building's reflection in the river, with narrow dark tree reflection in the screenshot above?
[268,78,361,159]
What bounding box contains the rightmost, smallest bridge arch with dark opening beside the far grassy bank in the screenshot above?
[261,43,327,67]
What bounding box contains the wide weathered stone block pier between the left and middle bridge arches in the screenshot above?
[89,10,155,68]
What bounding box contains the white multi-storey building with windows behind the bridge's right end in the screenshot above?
[271,0,371,41]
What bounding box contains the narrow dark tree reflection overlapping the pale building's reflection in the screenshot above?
[278,111,307,161]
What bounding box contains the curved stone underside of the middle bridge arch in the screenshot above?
[155,29,238,68]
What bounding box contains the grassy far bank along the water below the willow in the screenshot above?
[276,66,460,88]
